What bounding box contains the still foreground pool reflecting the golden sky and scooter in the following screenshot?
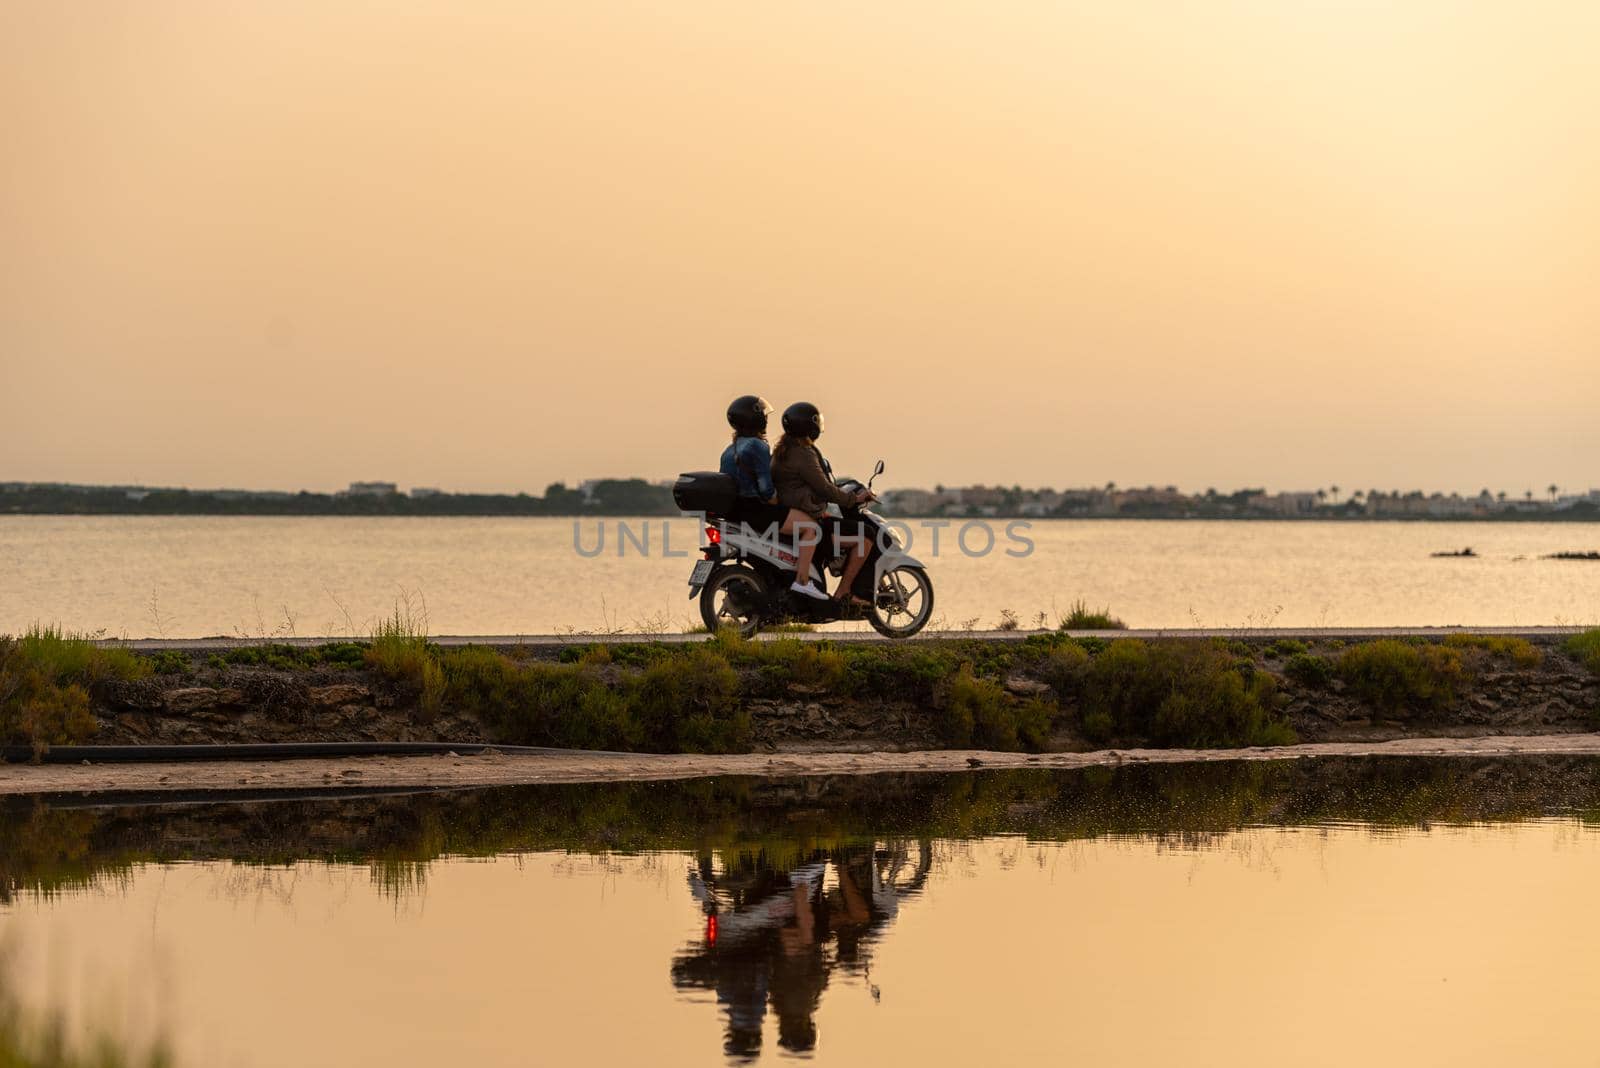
[0,758,1600,1065]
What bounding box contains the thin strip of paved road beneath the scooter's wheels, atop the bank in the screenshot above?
[99,627,1586,652]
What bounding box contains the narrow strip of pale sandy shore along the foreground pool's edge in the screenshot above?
[0,734,1600,795]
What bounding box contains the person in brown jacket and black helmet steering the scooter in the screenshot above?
[773,401,872,601]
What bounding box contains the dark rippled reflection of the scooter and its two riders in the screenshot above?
[672,843,933,1057]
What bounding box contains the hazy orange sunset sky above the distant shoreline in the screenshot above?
[0,0,1600,496]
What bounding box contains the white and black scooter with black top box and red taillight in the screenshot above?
[672,460,933,638]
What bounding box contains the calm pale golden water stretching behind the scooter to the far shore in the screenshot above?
[0,516,1600,638]
